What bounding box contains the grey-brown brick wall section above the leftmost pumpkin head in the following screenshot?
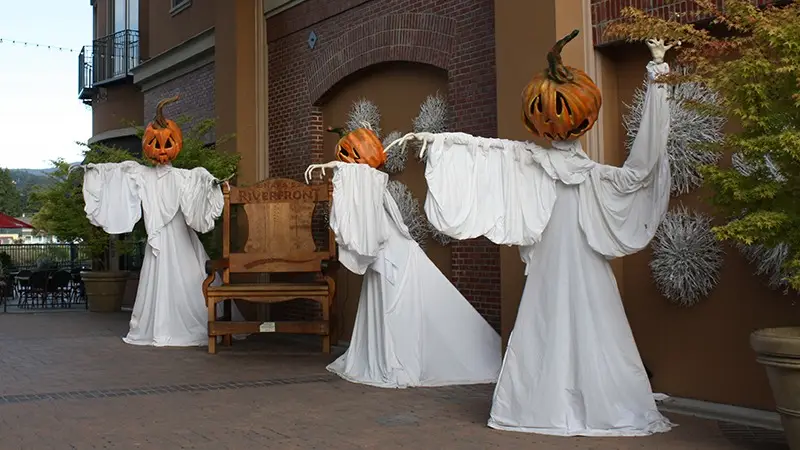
[144,63,216,142]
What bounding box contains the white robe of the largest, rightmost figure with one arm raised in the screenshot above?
[423,62,672,436]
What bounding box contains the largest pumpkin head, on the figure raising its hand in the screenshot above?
[522,30,602,141]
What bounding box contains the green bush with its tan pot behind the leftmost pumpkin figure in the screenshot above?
[31,118,240,312]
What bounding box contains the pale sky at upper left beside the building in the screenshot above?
[0,0,92,169]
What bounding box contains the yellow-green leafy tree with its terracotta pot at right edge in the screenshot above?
[607,0,800,449]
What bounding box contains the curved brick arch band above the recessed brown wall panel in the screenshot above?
[308,13,456,105]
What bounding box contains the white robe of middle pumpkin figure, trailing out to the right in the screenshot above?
[328,164,502,388]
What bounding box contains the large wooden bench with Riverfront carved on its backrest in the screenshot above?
[203,178,336,354]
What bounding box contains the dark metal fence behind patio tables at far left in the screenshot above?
[0,244,92,270]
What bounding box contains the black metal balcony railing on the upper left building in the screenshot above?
[78,30,140,100]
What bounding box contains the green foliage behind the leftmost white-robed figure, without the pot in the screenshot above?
[31,120,239,268]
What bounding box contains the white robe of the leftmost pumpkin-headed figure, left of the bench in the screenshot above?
[83,161,238,347]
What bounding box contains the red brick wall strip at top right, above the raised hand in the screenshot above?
[591,0,781,46]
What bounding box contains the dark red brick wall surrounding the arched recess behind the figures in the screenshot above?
[267,0,500,327]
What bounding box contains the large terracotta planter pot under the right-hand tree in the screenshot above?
[750,327,800,450]
